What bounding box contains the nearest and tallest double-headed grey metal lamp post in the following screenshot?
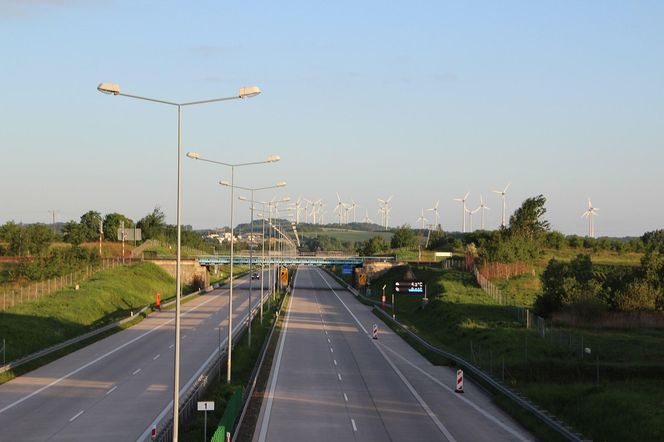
[97,83,261,442]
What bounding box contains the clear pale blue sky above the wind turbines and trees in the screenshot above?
[0,0,664,236]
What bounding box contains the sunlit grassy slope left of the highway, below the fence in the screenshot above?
[0,263,175,361]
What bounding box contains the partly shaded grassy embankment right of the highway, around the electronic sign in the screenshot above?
[366,267,664,441]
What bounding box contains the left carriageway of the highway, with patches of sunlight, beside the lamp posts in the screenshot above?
[0,277,268,442]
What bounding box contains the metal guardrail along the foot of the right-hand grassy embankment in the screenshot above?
[328,272,587,442]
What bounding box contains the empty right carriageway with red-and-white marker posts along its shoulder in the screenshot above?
[253,267,533,442]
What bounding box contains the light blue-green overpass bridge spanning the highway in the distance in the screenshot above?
[196,255,396,266]
